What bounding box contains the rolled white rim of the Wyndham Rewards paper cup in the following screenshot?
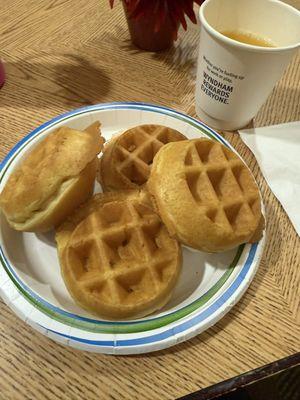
[199,0,300,53]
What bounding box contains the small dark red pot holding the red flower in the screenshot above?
[123,2,174,51]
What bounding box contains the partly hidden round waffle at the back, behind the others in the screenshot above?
[98,125,186,191]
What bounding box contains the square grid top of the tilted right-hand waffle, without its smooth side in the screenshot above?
[184,141,260,231]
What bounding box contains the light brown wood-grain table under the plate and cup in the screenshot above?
[0,0,300,400]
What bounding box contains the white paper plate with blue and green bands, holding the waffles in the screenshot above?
[0,103,264,354]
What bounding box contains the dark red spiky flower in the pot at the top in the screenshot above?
[109,0,204,39]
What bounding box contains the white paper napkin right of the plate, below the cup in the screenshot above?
[239,121,300,236]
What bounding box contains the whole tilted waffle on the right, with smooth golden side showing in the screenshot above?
[147,139,264,252]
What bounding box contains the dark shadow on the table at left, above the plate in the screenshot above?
[0,54,111,110]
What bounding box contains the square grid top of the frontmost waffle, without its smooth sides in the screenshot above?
[69,201,176,305]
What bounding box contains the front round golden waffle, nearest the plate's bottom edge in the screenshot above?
[56,191,181,319]
